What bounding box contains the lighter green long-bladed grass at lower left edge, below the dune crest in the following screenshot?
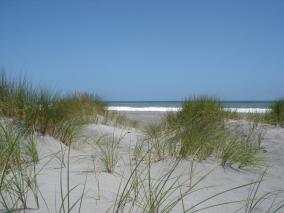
[0,121,39,212]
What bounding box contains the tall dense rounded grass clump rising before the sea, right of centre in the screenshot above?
[165,97,224,159]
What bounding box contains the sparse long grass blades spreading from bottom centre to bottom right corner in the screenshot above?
[109,150,284,213]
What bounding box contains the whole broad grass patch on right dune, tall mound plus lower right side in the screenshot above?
[143,97,263,167]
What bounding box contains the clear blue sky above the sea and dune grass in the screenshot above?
[0,0,284,100]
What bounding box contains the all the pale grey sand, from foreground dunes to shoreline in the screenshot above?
[21,112,284,213]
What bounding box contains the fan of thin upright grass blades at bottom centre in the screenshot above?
[112,155,187,213]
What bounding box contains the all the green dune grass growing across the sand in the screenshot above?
[0,73,283,213]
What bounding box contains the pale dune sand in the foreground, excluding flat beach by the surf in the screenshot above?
[27,120,284,213]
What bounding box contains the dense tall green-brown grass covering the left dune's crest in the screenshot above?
[0,72,106,143]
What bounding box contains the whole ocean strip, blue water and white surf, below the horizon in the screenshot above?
[108,101,272,113]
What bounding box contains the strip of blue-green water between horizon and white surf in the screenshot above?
[108,101,272,108]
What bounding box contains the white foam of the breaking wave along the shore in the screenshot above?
[108,106,270,113]
